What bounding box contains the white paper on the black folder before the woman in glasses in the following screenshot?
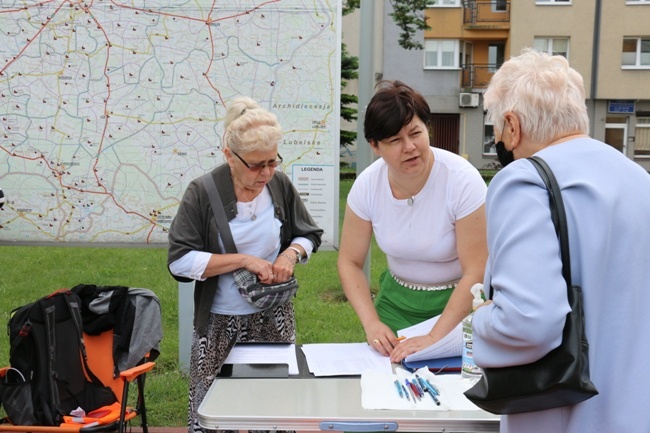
[224,343,300,375]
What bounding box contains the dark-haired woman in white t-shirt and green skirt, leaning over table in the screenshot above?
[338,81,487,362]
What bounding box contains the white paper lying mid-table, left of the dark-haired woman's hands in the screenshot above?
[302,343,392,376]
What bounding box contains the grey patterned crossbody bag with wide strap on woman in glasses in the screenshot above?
[201,173,298,310]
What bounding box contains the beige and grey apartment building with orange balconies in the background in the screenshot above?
[362,0,650,171]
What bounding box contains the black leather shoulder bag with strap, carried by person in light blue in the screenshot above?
[465,156,598,414]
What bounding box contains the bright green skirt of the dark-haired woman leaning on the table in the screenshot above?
[375,269,454,334]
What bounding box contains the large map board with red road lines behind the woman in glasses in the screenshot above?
[0,0,341,247]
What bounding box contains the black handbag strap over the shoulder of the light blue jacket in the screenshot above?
[528,156,571,287]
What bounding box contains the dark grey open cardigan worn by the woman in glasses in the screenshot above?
[167,164,323,335]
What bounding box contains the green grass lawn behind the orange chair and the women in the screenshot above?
[0,180,386,427]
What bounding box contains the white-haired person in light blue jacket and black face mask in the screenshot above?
[472,50,650,433]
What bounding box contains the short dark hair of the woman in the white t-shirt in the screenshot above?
[363,80,431,142]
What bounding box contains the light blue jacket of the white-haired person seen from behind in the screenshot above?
[473,138,650,433]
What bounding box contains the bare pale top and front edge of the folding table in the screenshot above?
[198,376,500,432]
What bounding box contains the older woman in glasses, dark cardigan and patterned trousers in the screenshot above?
[168,97,323,432]
